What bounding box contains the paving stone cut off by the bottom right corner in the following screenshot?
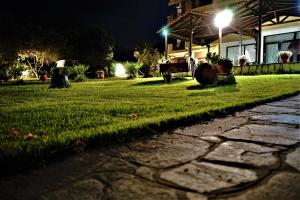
[219,172,300,200]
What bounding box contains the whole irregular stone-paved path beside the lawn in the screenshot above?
[0,95,300,200]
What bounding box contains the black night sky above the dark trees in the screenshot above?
[0,0,168,47]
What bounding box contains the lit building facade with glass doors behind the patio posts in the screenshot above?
[164,0,300,64]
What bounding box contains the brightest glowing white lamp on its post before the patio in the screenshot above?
[215,10,233,56]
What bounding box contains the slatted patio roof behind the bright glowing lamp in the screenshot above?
[158,0,300,45]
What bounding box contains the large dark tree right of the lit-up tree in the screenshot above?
[62,26,114,77]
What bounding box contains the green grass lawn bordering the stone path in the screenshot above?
[0,75,300,159]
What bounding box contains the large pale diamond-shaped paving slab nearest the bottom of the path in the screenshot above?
[160,161,258,193]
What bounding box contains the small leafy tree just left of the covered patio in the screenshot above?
[134,45,162,77]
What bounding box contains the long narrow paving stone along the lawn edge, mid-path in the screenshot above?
[174,116,248,137]
